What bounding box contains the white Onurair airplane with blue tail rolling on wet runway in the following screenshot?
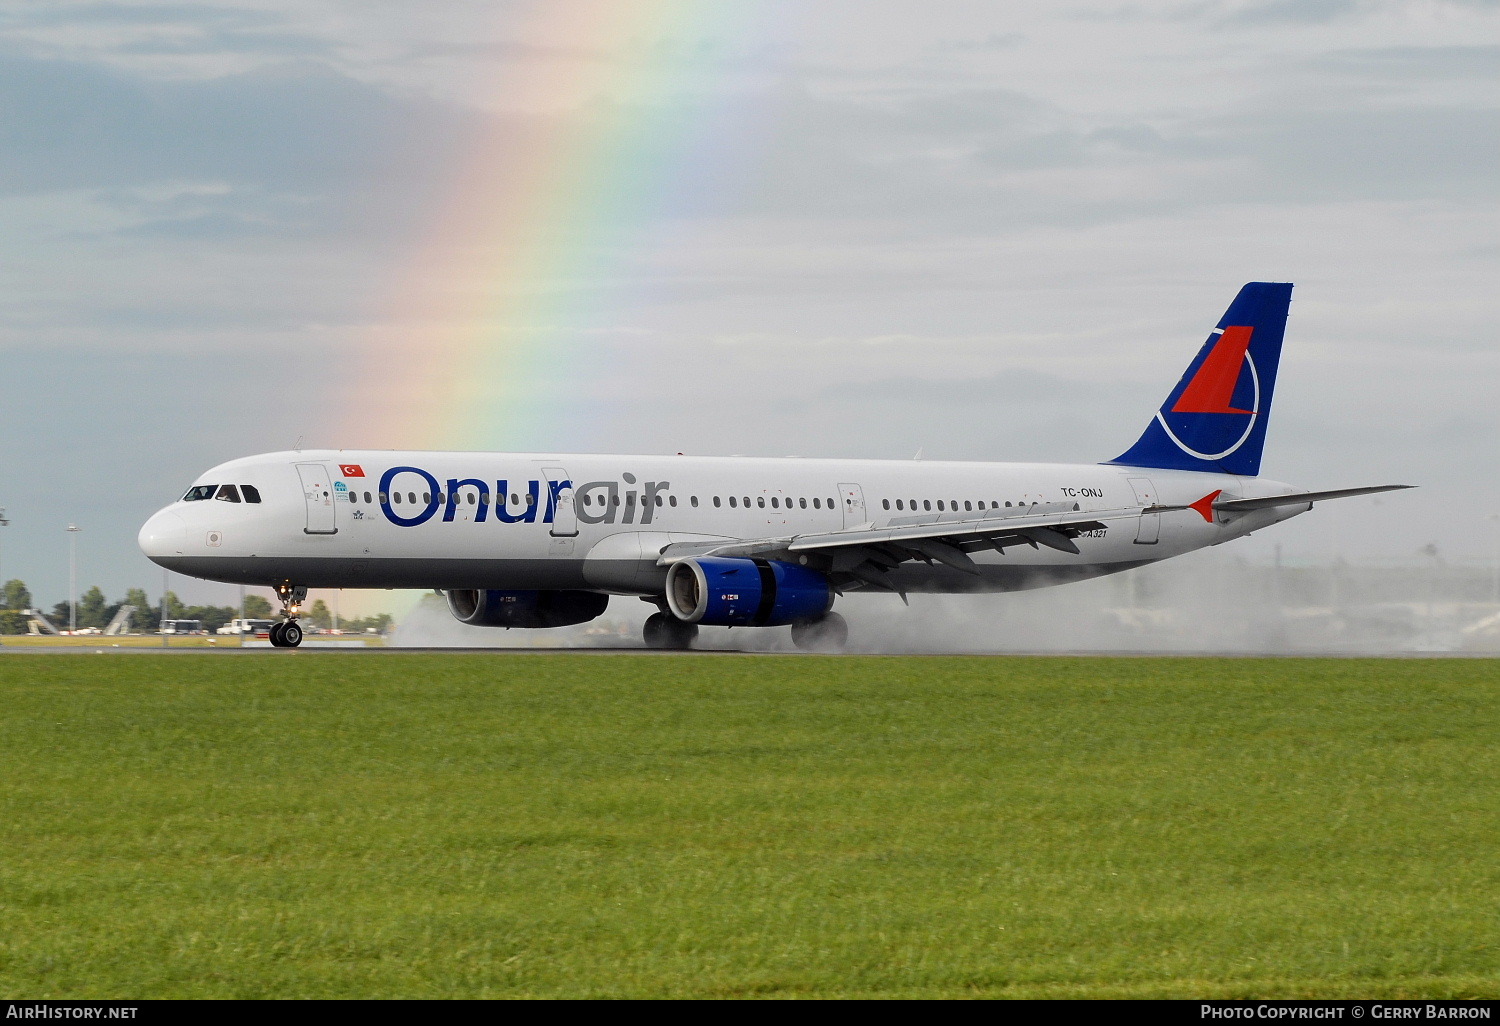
[138,282,1412,651]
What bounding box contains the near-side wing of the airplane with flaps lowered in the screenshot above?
[657,503,1142,597]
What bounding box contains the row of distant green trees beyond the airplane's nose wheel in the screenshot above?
[0,579,392,635]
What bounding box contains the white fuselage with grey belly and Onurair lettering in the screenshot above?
[140,450,1308,596]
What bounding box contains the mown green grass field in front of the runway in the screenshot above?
[0,653,1500,998]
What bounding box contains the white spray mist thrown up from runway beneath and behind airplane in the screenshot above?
[390,552,1500,656]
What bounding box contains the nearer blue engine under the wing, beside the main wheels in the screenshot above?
[666,557,834,627]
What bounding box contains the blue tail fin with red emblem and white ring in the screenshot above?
[1109,282,1292,477]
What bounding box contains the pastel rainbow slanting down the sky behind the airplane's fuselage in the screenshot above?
[349,0,762,450]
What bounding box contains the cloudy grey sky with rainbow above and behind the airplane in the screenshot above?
[0,0,1500,606]
